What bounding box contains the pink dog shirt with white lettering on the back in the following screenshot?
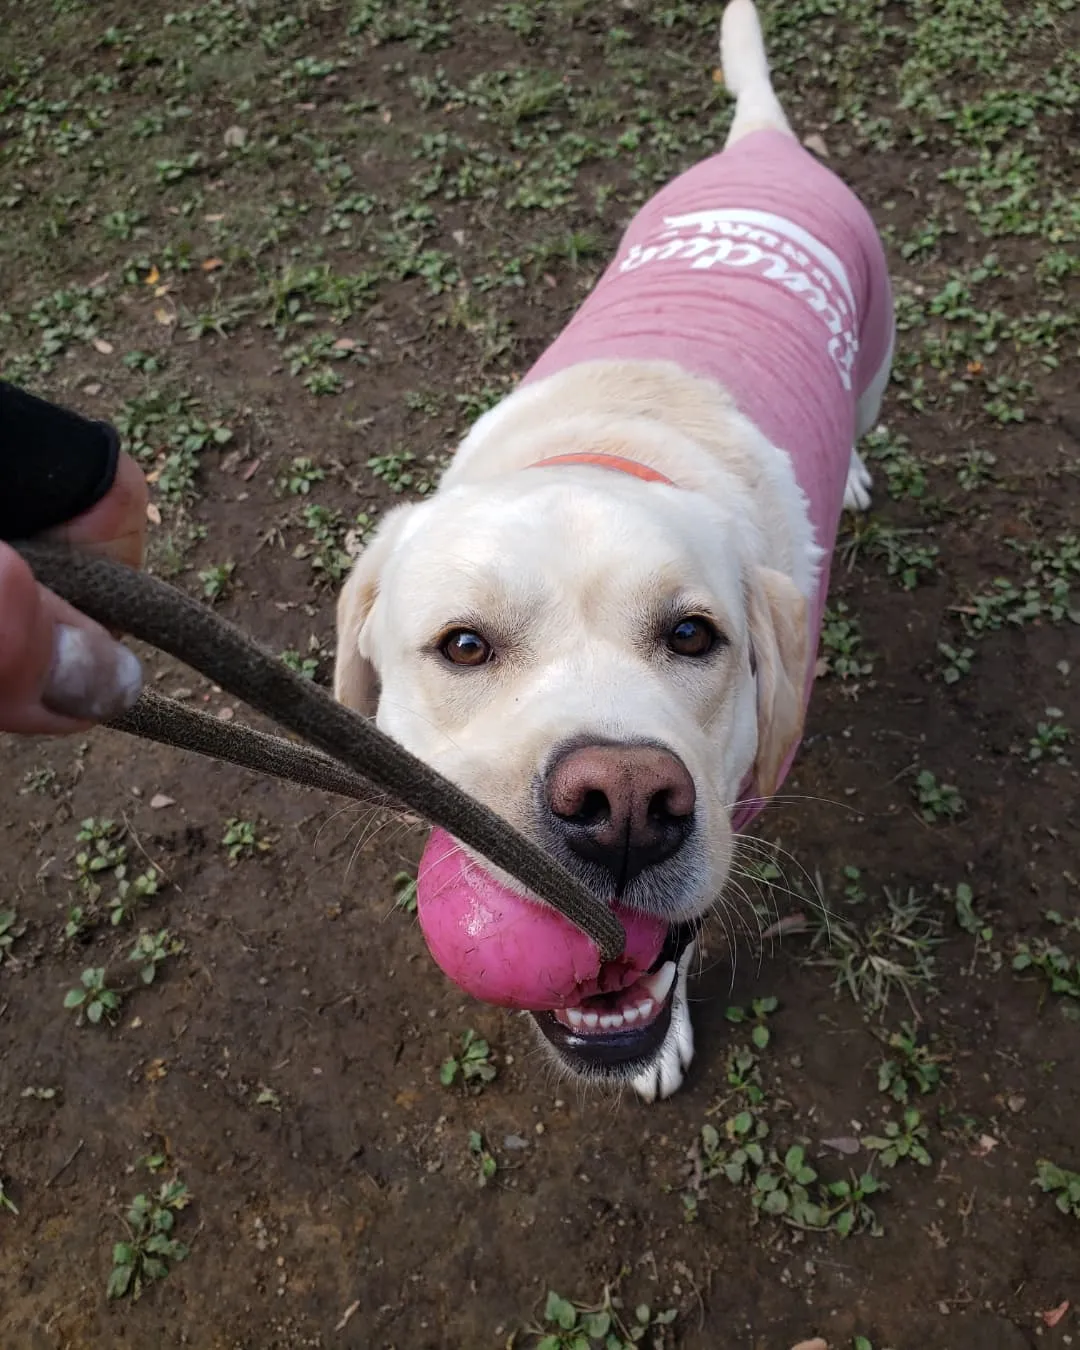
[524,131,892,828]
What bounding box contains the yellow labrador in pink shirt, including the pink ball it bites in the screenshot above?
[335,0,894,1100]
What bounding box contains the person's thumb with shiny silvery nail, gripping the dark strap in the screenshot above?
[0,544,142,736]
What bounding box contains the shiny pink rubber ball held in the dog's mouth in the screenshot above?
[416,830,667,1013]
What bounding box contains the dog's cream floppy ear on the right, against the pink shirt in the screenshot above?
[749,567,810,798]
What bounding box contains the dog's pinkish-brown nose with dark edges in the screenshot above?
[544,745,697,894]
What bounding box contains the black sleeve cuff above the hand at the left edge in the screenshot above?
[0,379,120,540]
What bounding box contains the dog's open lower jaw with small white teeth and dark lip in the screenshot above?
[529,923,698,1084]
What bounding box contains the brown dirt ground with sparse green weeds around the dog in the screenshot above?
[0,0,1080,1350]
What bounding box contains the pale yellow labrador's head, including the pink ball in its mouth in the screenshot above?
[335,446,807,1079]
